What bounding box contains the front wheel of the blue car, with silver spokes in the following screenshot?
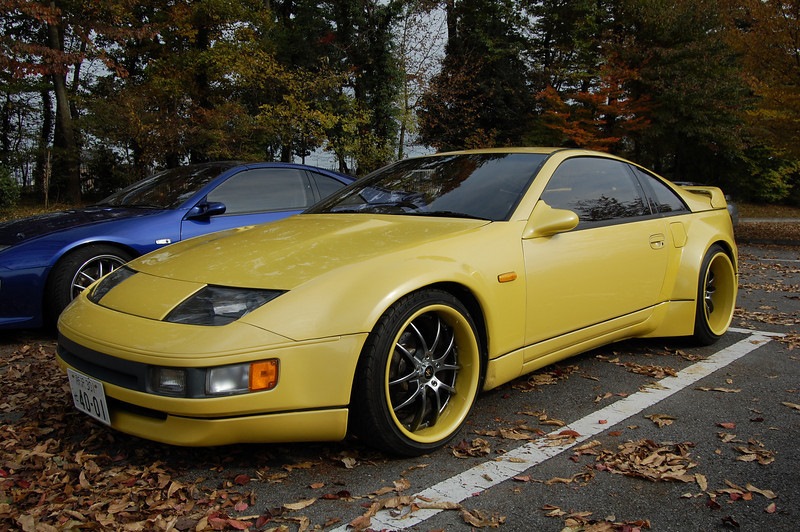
[45,244,134,326]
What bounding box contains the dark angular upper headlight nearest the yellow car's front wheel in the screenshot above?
[165,285,283,325]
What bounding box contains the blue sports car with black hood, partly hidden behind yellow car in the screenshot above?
[0,162,354,330]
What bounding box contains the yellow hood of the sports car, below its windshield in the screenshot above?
[131,214,490,290]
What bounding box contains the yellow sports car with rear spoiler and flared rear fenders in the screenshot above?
[58,148,737,455]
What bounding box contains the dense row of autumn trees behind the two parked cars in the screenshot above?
[0,0,800,208]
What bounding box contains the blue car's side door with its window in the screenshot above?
[181,168,316,239]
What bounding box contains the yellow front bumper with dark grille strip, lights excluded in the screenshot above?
[57,298,366,446]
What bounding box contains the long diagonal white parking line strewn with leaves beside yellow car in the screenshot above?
[335,328,783,532]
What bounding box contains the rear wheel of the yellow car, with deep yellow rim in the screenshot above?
[692,244,737,345]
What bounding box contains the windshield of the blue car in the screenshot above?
[98,162,238,209]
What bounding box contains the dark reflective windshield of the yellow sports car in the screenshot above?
[306,153,547,221]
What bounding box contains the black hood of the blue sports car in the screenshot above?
[0,207,161,246]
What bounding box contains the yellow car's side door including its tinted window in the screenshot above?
[523,157,669,357]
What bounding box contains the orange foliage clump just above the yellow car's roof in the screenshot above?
[538,62,651,152]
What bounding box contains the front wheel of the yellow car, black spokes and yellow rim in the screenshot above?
[351,290,482,456]
